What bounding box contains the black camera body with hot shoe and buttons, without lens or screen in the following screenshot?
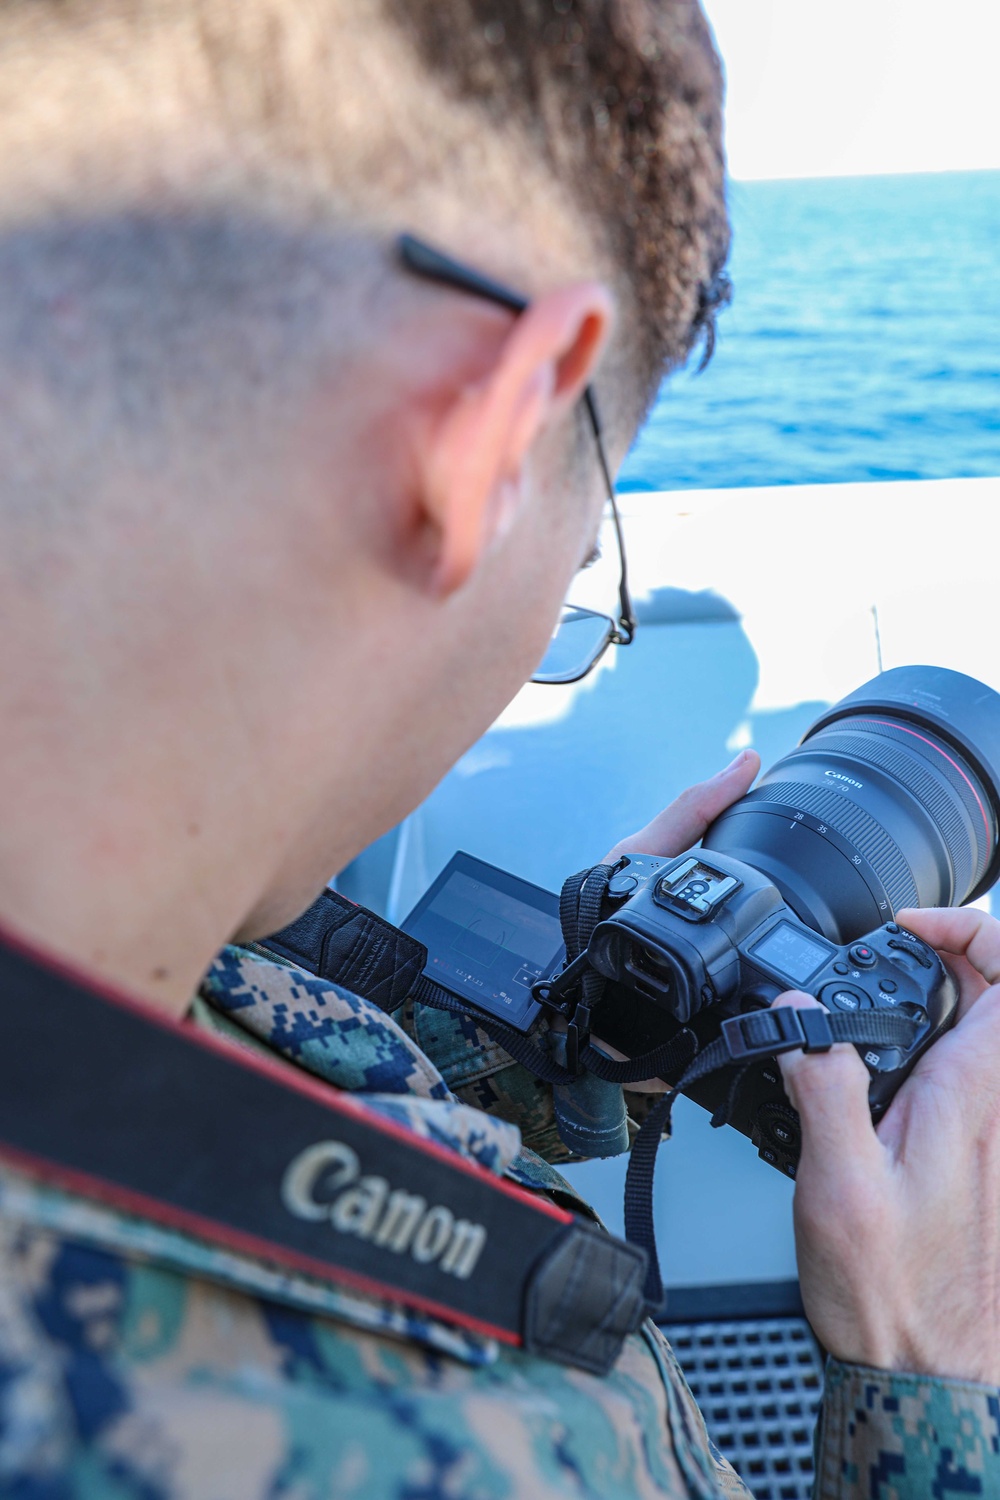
[588,849,958,1178]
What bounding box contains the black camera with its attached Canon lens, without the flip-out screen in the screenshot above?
[575,666,1000,1176]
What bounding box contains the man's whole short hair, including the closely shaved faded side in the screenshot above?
[0,0,729,452]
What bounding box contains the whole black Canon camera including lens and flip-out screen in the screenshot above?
[389,666,1000,1176]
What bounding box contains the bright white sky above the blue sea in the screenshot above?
[703,0,1000,182]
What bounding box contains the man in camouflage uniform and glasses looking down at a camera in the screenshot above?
[0,0,1000,1497]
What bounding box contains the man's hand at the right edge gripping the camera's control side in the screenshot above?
[778,911,1000,1385]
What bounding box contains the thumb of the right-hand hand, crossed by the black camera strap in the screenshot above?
[772,990,880,1173]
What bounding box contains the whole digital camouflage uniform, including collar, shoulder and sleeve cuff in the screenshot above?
[0,950,1000,1500]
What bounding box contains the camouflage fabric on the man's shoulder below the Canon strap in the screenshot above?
[0,1206,749,1500]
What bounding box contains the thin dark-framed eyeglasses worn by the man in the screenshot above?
[396,234,636,683]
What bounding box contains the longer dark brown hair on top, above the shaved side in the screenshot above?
[384,0,730,399]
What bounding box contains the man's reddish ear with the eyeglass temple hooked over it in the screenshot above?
[421,282,613,594]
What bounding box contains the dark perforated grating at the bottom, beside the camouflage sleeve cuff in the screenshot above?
[664,1317,823,1500]
